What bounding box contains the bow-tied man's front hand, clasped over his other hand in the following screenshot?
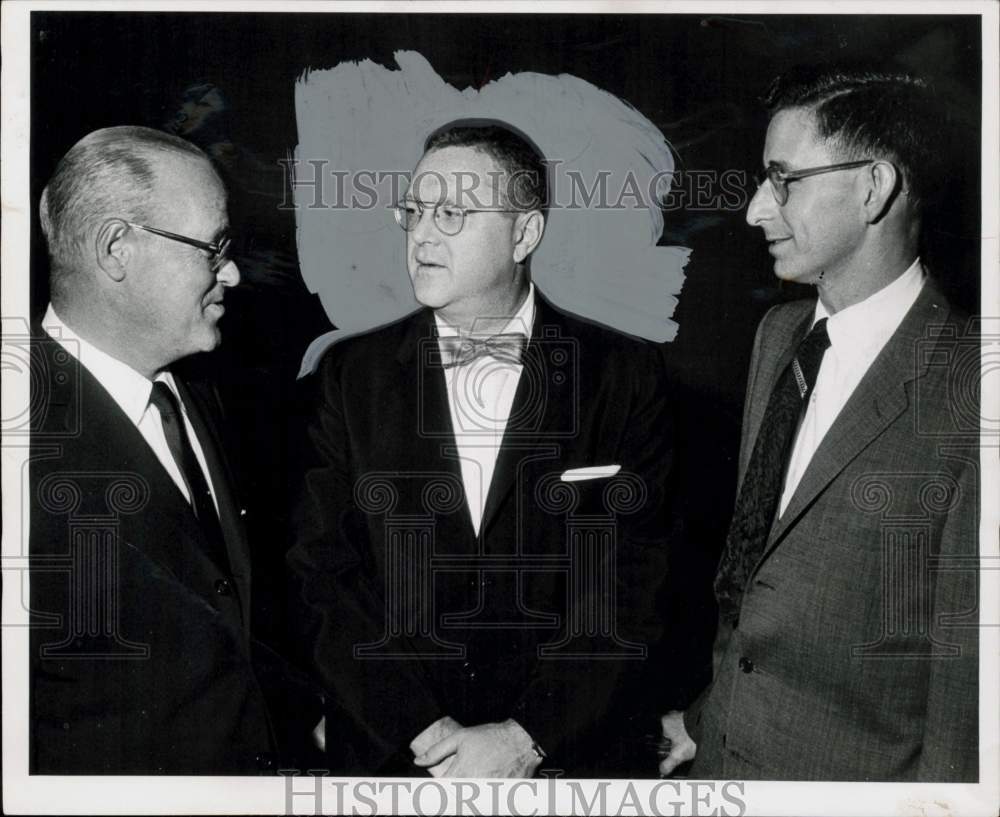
[413,720,542,777]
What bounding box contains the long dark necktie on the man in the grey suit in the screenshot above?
[715,318,830,622]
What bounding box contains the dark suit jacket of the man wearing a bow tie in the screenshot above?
[290,298,671,774]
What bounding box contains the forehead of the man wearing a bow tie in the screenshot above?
[408,147,503,206]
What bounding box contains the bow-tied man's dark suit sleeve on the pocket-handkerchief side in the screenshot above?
[504,346,675,762]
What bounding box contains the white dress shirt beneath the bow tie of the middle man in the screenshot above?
[434,284,535,536]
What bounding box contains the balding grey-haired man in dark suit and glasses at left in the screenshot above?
[29,127,318,774]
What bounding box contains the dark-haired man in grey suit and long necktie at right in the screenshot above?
[661,70,980,782]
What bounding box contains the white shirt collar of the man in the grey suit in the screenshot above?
[813,258,927,354]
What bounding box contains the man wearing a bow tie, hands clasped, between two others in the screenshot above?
[290,122,671,777]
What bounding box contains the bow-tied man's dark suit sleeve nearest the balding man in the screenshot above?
[288,352,444,774]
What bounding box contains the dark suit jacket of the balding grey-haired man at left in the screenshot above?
[29,332,318,774]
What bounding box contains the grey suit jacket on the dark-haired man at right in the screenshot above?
[691,284,979,781]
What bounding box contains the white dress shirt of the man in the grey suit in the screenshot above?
[778,258,927,516]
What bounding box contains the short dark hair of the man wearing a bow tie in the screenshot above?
[424,119,549,212]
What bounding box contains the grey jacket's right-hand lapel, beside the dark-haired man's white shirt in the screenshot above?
[764,283,948,556]
